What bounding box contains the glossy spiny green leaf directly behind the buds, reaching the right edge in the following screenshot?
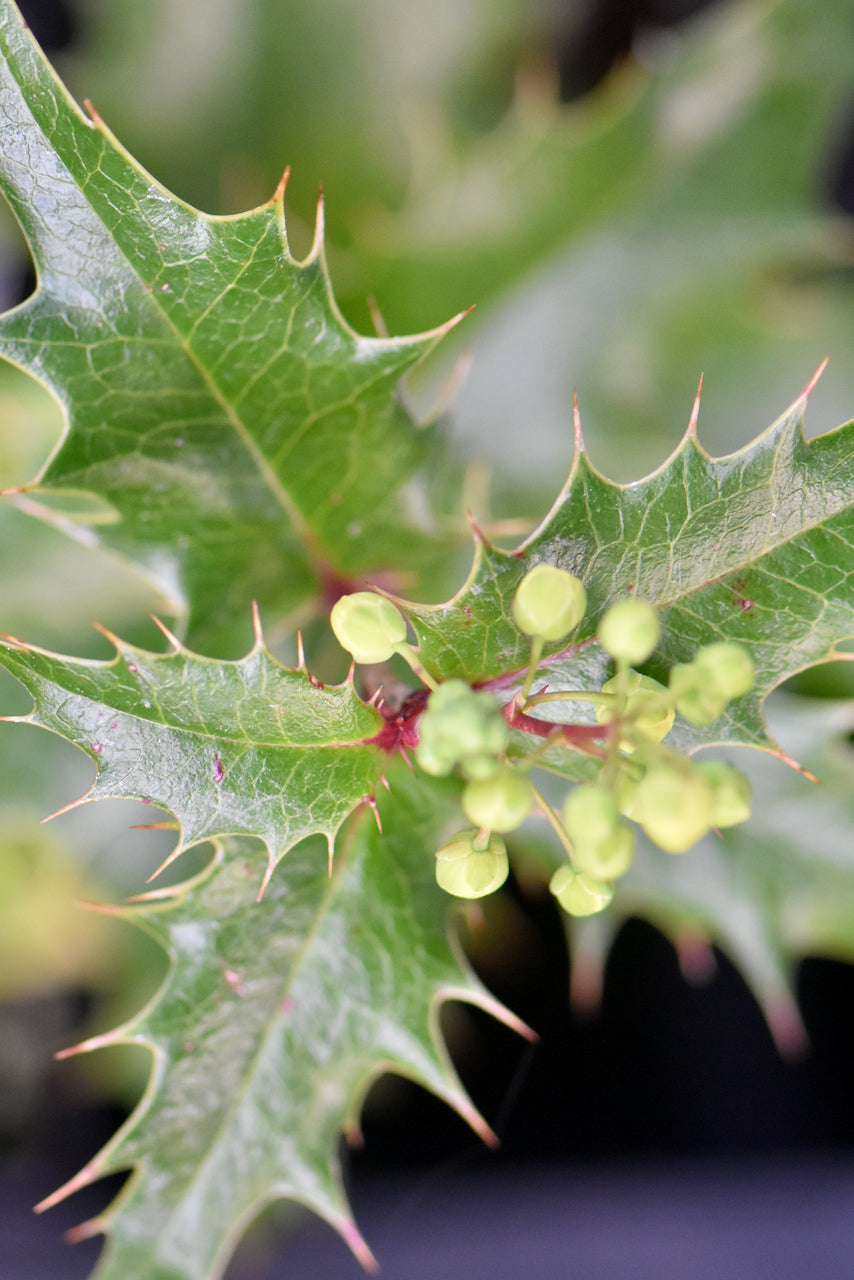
[407,373,854,763]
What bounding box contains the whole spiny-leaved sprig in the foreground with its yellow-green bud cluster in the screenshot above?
[0,0,854,1280]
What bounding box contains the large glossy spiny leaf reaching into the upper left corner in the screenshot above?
[0,0,453,652]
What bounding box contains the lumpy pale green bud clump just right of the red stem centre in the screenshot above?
[415,680,510,777]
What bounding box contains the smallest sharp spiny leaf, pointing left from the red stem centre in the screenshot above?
[0,627,385,891]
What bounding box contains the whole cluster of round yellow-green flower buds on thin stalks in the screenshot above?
[332,576,754,915]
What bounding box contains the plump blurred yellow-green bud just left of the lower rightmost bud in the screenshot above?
[631,762,714,854]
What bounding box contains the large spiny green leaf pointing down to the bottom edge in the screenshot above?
[41,765,525,1280]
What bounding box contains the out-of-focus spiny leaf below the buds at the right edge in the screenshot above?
[615,695,854,1050]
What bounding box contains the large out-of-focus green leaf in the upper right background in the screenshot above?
[453,0,854,483]
